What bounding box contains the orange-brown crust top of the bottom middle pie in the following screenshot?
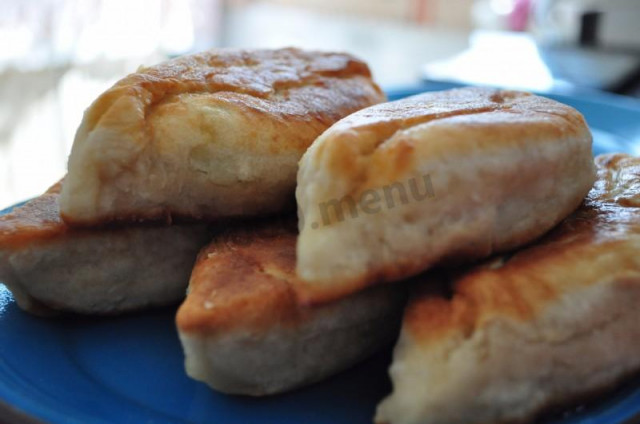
[176,218,340,334]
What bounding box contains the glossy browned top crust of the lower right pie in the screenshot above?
[405,154,640,344]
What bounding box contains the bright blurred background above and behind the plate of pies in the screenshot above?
[0,0,640,207]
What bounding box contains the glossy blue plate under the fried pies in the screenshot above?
[0,84,640,424]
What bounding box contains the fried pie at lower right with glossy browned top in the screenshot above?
[376,154,640,424]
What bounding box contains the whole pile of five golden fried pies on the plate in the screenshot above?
[0,48,640,424]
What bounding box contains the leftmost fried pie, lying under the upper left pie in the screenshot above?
[0,183,211,315]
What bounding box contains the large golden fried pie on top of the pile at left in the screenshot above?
[60,49,384,225]
